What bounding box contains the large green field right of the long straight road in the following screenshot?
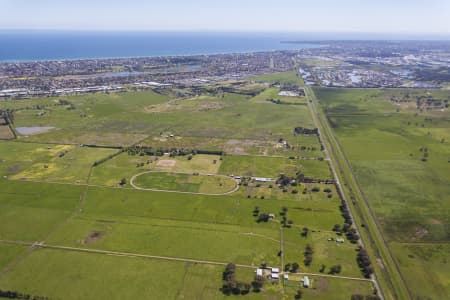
[316,89,450,299]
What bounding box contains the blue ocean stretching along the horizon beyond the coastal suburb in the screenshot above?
[0,30,318,62]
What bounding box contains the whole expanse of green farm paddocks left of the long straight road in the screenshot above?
[0,84,372,299]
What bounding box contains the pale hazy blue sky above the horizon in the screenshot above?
[0,0,450,34]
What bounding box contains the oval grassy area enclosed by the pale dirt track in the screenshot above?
[133,171,236,194]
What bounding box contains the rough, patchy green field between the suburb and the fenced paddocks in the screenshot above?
[7,92,312,145]
